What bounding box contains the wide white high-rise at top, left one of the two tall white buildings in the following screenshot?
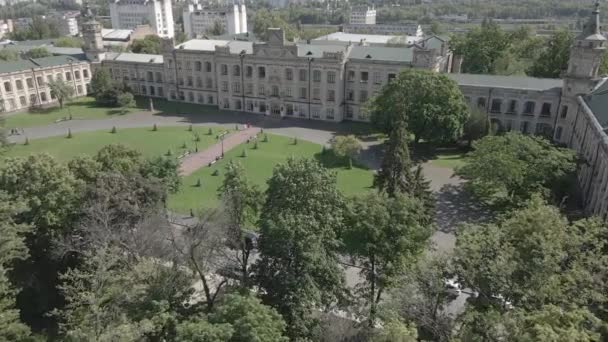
[110,0,175,38]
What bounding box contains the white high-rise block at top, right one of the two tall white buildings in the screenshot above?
[183,3,247,38]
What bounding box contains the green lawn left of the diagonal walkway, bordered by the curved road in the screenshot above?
[6,127,226,161]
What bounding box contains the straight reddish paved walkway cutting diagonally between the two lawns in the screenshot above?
[179,127,260,176]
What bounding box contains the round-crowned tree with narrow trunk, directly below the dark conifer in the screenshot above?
[344,193,432,327]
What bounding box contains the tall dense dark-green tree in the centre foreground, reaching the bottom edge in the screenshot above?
[254,158,344,339]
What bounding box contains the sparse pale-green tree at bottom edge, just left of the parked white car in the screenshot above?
[382,254,457,341]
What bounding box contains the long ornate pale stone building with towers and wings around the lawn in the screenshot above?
[0,0,608,219]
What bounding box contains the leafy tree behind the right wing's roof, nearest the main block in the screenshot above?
[450,20,511,74]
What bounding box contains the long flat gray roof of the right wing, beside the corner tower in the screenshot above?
[446,74,562,91]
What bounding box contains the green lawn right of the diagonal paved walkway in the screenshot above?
[169,135,373,213]
